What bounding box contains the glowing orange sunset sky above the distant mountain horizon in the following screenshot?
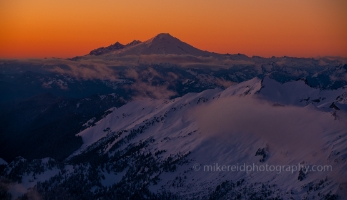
[0,0,347,58]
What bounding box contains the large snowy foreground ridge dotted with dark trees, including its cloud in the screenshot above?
[0,77,347,199]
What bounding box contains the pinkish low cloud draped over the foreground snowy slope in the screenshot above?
[195,97,347,159]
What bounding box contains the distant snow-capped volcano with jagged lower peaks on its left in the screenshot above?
[89,33,213,56]
